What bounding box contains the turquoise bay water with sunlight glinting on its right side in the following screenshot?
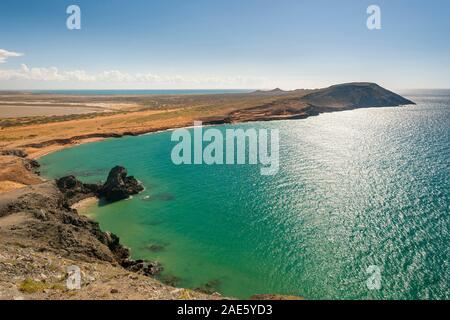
[41,95,450,299]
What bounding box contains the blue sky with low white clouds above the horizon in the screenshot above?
[0,0,450,89]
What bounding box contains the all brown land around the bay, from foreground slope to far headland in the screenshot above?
[0,83,414,299]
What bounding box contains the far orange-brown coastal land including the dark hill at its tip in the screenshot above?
[0,83,412,192]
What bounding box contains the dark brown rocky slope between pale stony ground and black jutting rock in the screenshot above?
[0,181,129,264]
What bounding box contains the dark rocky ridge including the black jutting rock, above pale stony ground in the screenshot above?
[0,167,158,276]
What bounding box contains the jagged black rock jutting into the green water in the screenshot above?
[98,166,144,201]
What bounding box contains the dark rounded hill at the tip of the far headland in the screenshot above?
[300,82,415,109]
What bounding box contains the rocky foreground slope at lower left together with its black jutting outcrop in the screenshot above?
[0,166,215,299]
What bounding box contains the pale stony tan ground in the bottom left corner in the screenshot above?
[0,241,215,300]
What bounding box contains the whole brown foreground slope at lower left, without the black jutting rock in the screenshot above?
[0,182,219,299]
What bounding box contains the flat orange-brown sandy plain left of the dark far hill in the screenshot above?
[0,90,309,192]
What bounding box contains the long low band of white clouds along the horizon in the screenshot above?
[0,64,266,88]
